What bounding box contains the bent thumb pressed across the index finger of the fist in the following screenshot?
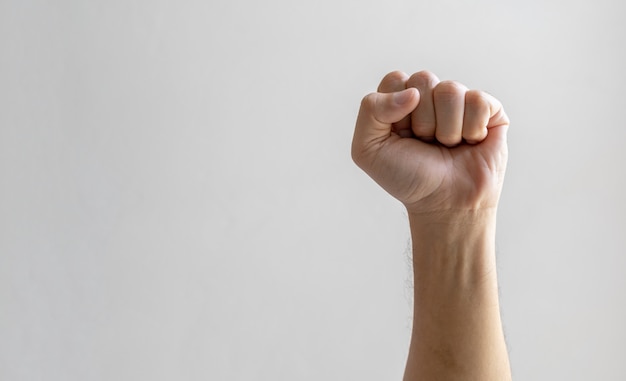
[352,88,420,164]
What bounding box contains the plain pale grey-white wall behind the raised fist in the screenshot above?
[0,0,626,381]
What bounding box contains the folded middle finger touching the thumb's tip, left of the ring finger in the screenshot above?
[406,70,439,141]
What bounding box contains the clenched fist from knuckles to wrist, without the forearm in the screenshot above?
[352,71,509,216]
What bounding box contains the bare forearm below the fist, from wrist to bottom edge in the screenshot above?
[405,210,511,381]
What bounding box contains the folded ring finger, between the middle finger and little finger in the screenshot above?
[433,81,467,147]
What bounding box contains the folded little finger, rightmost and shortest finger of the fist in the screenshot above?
[463,90,491,144]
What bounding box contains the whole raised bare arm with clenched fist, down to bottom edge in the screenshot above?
[352,71,511,381]
